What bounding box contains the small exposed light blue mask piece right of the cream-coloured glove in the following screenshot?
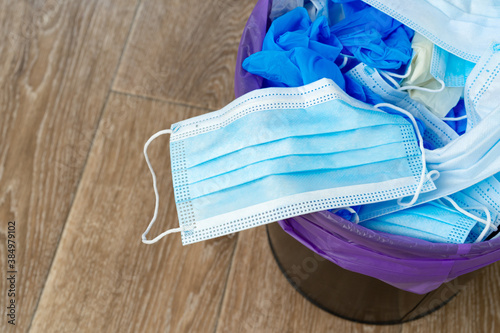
[430,45,476,87]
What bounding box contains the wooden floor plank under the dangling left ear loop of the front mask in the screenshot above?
[29,94,240,332]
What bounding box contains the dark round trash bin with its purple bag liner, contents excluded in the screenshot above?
[235,0,500,324]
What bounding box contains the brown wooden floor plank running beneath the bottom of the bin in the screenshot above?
[217,226,401,333]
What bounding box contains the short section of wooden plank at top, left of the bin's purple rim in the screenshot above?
[113,0,255,109]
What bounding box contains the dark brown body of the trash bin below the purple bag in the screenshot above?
[267,219,477,325]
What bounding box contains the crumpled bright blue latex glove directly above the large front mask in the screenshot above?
[243,7,345,89]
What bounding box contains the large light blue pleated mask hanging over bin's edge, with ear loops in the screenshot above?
[143,79,435,245]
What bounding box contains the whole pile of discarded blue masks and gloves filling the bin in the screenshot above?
[142,0,500,249]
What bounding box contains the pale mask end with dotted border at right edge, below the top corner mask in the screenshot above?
[464,44,500,131]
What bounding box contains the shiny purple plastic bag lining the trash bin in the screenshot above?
[234,0,500,294]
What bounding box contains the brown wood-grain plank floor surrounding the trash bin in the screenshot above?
[0,0,500,333]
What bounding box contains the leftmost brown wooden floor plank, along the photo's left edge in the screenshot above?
[0,0,136,332]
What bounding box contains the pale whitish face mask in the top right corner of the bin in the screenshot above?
[363,0,500,62]
